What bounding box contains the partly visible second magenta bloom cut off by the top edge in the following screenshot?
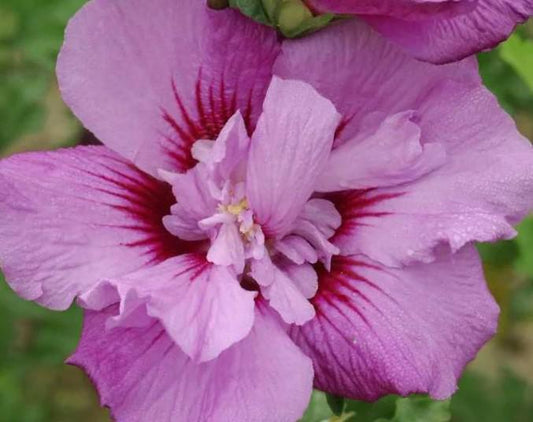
[306,0,533,63]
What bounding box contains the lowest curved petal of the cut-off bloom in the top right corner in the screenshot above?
[366,0,533,63]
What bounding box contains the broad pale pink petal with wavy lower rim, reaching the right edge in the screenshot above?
[333,83,533,266]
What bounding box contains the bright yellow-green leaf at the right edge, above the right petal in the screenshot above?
[499,33,533,92]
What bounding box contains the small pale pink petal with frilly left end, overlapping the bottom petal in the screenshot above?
[80,254,256,362]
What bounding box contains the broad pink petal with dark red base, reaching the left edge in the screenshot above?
[0,147,197,309]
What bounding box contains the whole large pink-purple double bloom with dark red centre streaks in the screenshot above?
[0,0,533,422]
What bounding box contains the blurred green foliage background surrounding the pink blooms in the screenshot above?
[0,0,533,422]
